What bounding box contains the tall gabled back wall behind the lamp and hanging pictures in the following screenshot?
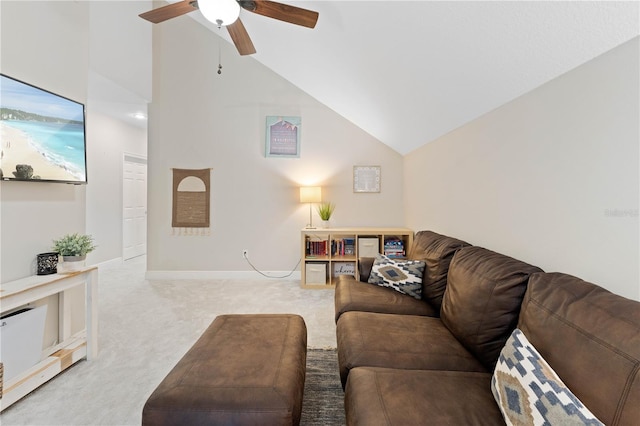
[147,19,404,276]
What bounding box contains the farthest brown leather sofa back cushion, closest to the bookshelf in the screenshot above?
[407,231,469,312]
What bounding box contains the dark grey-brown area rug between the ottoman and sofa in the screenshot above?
[300,349,345,426]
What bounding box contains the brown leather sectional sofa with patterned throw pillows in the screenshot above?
[335,231,640,425]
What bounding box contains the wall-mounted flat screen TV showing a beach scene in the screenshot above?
[0,74,87,184]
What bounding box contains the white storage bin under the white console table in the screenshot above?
[0,305,47,383]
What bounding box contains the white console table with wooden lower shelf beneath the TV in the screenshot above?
[0,266,98,411]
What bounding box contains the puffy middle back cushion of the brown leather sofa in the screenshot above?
[440,247,541,370]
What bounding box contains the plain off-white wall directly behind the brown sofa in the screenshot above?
[404,38,640,299]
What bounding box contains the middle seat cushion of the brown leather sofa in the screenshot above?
[336,312,487,386]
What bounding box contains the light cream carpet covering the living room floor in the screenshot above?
[0,257,343,426]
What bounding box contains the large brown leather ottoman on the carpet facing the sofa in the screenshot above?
[142,314,307,425]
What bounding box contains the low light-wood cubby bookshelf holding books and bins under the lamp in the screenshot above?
[300,228,413,289]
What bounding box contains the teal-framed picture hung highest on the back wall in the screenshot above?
[265,115,302,158]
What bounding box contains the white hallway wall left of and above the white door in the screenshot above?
[86,110,147,263]
